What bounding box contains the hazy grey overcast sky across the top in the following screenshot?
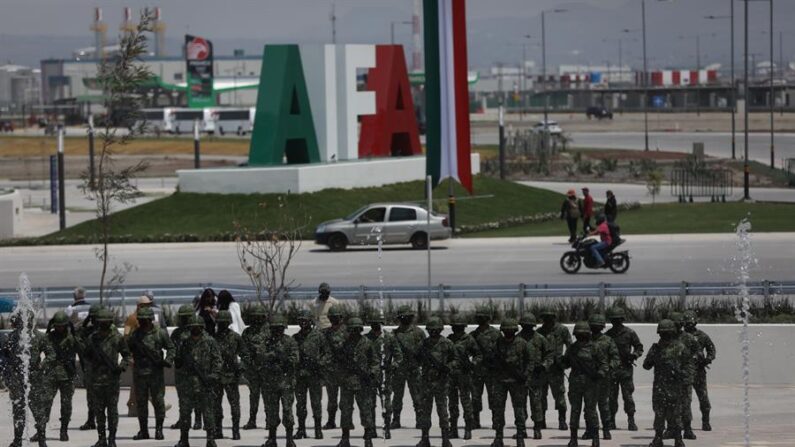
[0,0,795,68]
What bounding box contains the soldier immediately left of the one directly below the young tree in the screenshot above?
[39,311,78,442]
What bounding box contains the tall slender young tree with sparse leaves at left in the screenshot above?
[80,9,154,303]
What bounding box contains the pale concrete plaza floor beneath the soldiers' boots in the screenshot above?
[0,385,795,447]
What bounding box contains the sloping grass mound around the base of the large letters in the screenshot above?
[43,176,563,241]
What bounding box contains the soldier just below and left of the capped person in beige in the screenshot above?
[293,309,324,439]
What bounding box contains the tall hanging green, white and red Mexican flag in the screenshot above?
[423,0,472,193]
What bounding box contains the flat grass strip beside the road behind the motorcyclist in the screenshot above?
[466,202,795,237]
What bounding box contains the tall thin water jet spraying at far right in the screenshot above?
[734,219,755,447]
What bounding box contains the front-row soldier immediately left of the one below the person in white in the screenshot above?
[174,315,223,447]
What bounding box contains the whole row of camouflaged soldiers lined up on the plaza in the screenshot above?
[3,305,715,447]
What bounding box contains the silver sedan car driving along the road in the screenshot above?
[315,203,452,251]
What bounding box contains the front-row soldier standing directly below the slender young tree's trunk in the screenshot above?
[81,309,131,447]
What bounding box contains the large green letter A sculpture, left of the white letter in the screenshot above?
[248,45,320,166]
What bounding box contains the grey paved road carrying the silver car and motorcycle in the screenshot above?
[0,233,795,288]
